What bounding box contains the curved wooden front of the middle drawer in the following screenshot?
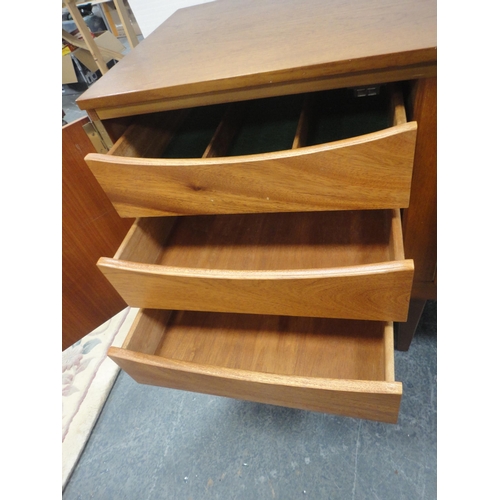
[99,259,413,321]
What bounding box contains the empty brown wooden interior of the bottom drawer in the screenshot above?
[124,310,394,381]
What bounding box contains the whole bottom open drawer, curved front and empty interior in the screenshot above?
[108,309,402,423]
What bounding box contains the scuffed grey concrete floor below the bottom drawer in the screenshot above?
[63,301,437,500]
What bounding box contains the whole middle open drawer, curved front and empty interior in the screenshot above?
[98,210,413,321]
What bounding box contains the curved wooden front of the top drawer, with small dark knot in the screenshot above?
[85,122,417,217]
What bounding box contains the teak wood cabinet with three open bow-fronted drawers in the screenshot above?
[78,0,436,422]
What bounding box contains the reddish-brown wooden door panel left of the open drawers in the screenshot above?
[62,118,133,350]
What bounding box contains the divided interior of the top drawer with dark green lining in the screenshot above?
[110,85,406,158]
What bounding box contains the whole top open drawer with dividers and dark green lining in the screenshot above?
[85,86,417,217]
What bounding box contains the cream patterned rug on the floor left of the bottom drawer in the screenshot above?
[62,307,138,488]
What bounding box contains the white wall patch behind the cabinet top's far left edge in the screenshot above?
[128,0,214,38]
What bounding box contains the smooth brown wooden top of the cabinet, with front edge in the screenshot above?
[77,0,437,114]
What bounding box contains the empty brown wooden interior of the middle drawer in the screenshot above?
[115,210,404,270]
